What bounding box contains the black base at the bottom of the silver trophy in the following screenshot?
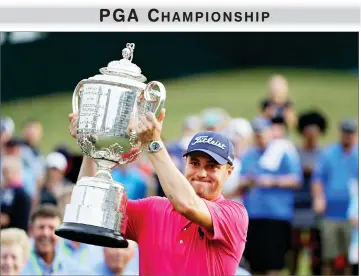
[55,222,128,248]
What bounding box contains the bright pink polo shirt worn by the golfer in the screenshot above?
[125,196,248,275]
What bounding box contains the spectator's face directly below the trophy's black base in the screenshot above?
[104,247,134,274]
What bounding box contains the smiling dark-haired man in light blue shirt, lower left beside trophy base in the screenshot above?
[22,205,91,275]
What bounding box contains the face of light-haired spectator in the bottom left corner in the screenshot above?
[1,244,25,276]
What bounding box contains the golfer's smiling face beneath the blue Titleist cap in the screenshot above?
[184,152,233,200]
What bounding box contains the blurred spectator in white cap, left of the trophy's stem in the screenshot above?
[39,152,72,205]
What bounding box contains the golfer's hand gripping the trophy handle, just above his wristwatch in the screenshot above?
[137,108,165,145]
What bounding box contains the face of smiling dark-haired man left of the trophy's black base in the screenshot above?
[31,217,61,255]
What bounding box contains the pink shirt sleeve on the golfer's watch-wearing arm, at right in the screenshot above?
[204,200,248,248]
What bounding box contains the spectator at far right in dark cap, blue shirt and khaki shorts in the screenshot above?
[312,119,358,275]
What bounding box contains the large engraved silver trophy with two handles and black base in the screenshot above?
[55,43,166,248]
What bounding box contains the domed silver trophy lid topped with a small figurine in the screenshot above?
[99,43,147,82]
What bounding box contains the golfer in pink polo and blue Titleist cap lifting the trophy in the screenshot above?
[69,110,248,275]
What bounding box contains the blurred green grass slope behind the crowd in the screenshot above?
[1,69,358,154]
